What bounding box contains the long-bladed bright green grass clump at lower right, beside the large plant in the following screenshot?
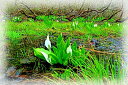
[53,53,123,81]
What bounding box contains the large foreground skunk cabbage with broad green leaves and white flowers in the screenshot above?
[34,34,72,65]
